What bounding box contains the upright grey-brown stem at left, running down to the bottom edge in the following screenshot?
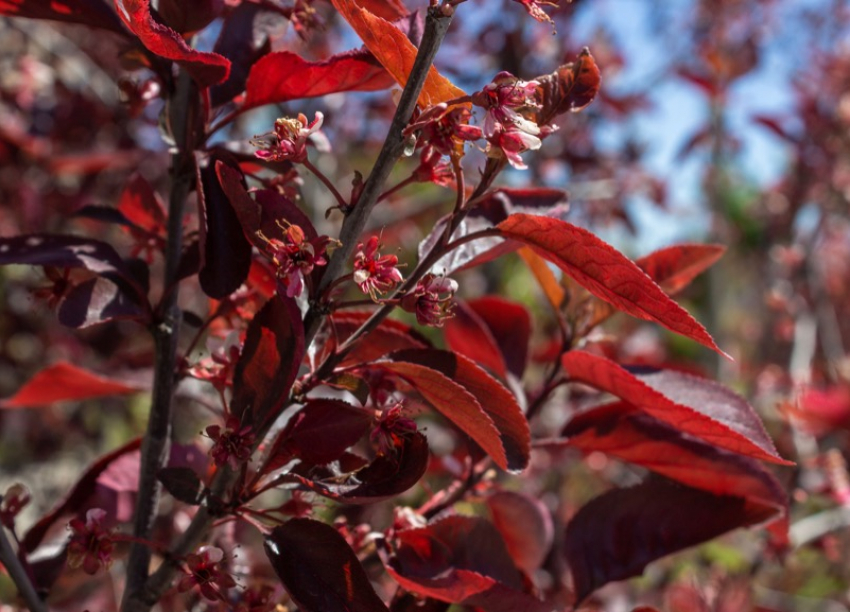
[123,73,198,610]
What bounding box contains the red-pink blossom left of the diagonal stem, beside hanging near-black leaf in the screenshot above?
[259,221,332,297]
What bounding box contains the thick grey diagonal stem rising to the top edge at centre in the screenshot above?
[304,7,452,344]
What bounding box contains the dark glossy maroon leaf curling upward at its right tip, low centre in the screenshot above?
[283,433,430,504]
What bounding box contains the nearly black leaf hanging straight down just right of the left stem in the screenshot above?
[198,155,251,300]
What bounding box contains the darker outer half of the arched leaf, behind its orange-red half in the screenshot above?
[390,349,531,471]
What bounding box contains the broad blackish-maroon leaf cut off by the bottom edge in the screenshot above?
[265,518,388,612]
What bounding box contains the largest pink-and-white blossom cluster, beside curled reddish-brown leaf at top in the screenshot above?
[472,72,557,170]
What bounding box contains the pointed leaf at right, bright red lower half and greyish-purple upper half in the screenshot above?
[561,351,793,465]
